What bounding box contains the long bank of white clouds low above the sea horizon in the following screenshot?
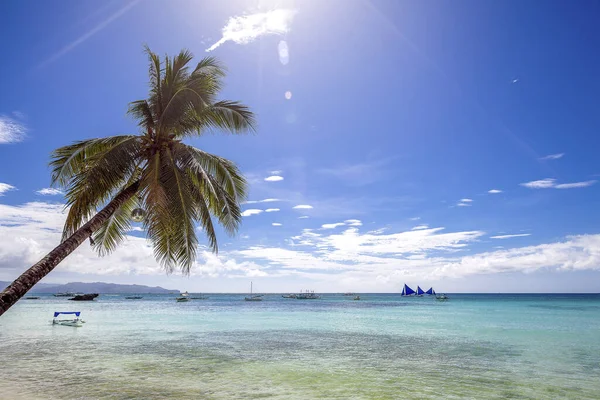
[0,202,600,290]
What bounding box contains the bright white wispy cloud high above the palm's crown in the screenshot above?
[206,9,296,52]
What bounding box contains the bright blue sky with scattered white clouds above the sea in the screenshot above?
[0,0,600,292]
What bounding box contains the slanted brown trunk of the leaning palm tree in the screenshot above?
[0,181,140,316]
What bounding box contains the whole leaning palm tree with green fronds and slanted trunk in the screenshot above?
[0,47,255,315]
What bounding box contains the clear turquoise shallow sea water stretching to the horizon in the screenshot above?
[0,294,600,399]
